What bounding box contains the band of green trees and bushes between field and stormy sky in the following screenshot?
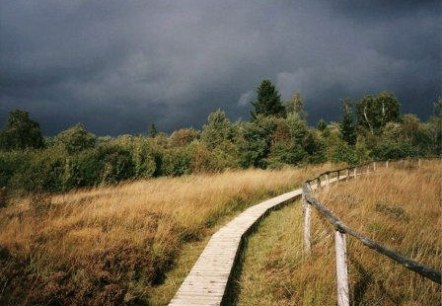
[0,80,442,193]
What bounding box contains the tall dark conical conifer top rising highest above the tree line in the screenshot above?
[251,80,285,119]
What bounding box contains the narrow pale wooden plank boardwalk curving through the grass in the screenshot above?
[169,188,302,306]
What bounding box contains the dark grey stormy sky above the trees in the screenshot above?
[0,0,442,135]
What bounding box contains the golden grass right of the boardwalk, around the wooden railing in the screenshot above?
[237,161,442,306]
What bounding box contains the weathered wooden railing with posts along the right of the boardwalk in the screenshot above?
[302,159,442,306]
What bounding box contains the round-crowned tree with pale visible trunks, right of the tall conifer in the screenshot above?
[356,91,400,134]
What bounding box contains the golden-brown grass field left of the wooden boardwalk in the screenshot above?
[0,166,326,305]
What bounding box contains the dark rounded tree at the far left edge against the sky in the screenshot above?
[0,110,44,150]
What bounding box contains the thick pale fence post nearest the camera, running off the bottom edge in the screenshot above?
[335,230,350,306]
